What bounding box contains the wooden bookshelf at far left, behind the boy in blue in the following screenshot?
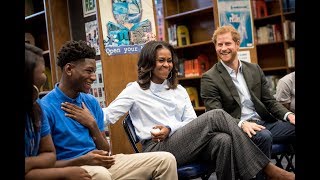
[25,0,71,91]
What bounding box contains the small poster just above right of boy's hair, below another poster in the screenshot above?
[84,20,100,55]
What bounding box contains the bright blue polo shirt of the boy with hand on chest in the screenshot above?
[40,84,104,160]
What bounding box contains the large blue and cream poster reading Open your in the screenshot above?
[99,0,156,56]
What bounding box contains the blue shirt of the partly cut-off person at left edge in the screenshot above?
[24,99,50,157]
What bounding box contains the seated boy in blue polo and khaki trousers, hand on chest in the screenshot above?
[40,40,178,180]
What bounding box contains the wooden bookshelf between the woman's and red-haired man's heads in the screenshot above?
[162,0,217,112]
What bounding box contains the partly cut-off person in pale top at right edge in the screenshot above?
[275,72,296,112]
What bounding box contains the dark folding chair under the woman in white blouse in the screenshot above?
[122,114,214,180]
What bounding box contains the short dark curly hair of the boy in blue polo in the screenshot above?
[57,40,96,69]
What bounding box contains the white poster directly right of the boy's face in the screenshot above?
[90,60,106,108]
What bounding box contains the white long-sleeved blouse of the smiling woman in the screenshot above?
[103,80,197,140]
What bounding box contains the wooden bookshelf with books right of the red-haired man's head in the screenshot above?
[251,0,295,76]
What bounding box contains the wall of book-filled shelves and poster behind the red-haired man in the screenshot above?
[162,0,295,112]
